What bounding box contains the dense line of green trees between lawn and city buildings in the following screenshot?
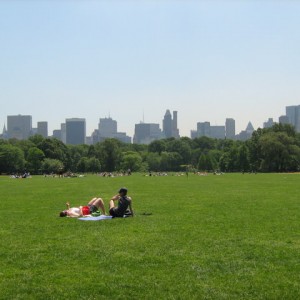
[0,124,300,174]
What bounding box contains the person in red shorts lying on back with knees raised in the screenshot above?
[59,198,106,218]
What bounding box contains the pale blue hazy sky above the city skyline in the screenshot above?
[0,0,300,136]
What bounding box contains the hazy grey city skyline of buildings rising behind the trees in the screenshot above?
[0,105,300,144]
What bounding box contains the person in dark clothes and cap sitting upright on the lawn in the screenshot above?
[109,188,133,218]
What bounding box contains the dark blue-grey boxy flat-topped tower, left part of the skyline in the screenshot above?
[66,118,86,145]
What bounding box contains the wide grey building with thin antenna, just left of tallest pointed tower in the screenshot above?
[133,123,163,144]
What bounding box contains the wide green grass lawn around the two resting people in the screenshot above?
[0,174,300,299]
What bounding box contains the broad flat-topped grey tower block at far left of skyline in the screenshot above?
[7,115,32,140]
